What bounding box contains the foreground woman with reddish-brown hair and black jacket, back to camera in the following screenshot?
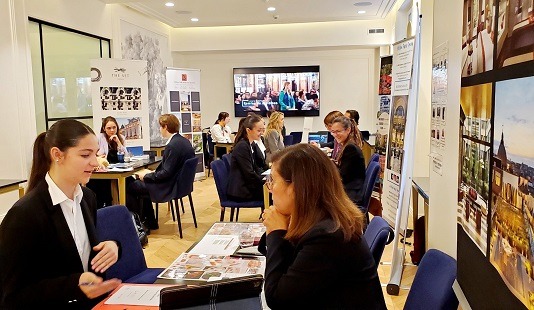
[259,144,386,309]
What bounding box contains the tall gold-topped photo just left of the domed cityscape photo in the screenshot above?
[457,83,492,255]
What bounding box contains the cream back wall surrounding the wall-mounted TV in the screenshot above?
[173,47,378,133]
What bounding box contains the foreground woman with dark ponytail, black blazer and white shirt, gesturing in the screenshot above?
[0,120,120,309]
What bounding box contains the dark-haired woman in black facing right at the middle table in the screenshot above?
[226,114,265,201]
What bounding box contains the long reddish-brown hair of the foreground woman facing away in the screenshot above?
[272,144,363,242]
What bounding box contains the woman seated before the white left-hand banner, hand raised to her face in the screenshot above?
[97,116,127,164]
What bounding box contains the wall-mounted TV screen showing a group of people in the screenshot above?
[234,66,320,117]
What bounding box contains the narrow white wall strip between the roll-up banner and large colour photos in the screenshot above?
[428,0,462,257]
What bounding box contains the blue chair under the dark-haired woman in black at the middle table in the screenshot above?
[211,159,264,222]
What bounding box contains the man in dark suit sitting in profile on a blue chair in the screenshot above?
[126,114,195,229]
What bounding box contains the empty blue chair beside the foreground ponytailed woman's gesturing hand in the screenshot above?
[96,206,164,284]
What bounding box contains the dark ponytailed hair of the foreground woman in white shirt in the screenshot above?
[28,119,95,191]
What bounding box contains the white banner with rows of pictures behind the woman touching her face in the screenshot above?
[91,59,150,151]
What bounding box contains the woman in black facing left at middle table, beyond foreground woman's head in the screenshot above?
[330,116,365,206]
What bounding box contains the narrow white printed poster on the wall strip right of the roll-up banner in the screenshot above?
[430,42,449,175]
